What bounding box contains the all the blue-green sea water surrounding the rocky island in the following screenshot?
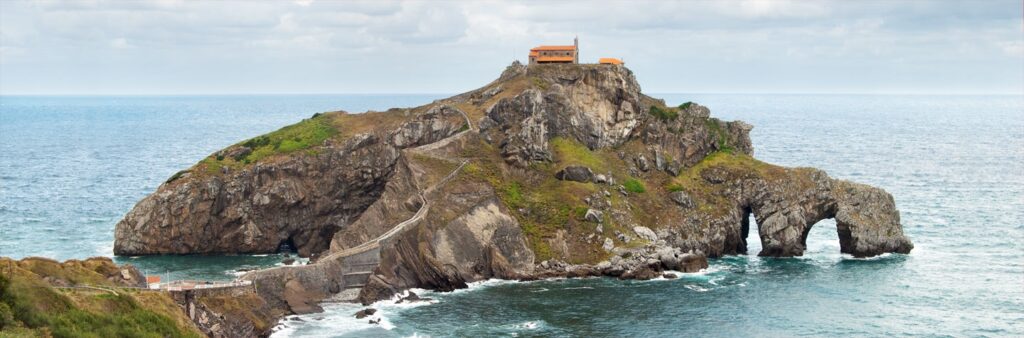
[0,94,1024,337]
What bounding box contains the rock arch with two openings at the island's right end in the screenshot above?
[735,169,913,257]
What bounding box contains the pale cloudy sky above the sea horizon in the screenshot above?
[0,0,1024,95]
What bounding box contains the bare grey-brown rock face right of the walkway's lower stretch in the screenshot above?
[358,182,534,304]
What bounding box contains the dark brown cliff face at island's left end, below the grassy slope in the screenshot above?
[114,105,464,256]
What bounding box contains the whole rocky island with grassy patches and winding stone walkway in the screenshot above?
[105,62,913,336]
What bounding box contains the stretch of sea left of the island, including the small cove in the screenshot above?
[0,95,436,280]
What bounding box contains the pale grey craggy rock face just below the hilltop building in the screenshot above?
[480,65,645,166]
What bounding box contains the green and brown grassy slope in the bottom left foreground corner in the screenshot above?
[0,258,202,337]
